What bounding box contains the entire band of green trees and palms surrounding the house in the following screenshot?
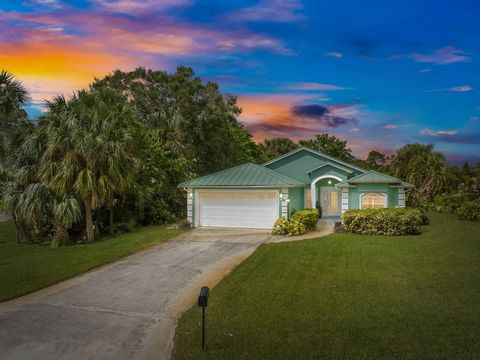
[0,67,480,245]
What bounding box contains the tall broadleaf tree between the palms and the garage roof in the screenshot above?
[92,67,258,175]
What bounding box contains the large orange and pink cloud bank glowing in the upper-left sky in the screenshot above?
[0,9,289,102]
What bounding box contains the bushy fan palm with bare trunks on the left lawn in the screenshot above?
[41,90,137,241]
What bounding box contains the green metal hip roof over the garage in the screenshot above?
[178,163,305,187]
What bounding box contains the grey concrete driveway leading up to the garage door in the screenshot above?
[0,229,270,360]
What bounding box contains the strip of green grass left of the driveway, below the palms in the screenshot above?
[0,221,181,301]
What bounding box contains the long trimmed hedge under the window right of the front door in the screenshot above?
[343,208,428,236]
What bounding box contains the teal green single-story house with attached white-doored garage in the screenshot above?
[179,147,412,229]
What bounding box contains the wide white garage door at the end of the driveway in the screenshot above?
[196,190,279,229]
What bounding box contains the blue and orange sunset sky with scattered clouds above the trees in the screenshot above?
[0,0,480,164]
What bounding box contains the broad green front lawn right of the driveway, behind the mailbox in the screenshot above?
[175,214,480,360]
